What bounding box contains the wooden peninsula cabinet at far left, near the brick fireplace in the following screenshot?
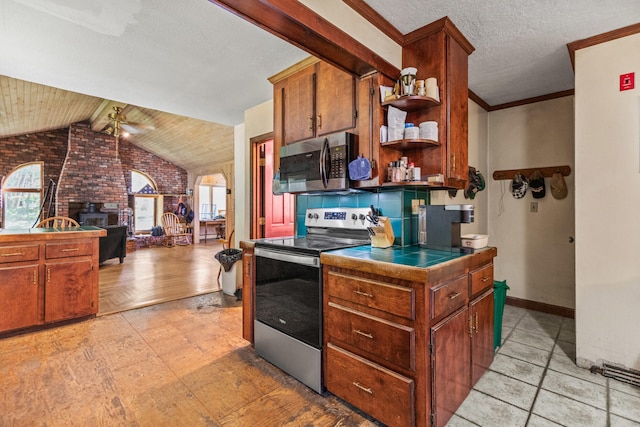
[0,226,107,334]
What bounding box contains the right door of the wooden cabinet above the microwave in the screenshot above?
[315,62,356,136]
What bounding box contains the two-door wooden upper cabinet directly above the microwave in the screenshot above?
[269,58,357,170]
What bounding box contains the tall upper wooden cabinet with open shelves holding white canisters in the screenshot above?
[354,18,474,189]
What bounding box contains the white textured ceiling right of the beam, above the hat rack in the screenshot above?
[365,0,640,106]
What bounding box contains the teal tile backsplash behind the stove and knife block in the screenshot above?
[296,188,429,246]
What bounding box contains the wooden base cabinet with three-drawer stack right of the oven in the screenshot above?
[321,248,497,426]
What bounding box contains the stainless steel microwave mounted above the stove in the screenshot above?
[280,132,356,193]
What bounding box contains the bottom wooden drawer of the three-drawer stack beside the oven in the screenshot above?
[325,344,415,427]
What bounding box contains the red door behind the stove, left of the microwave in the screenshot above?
[264,139,295,237]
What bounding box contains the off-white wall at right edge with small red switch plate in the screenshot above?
[575,34,640,369]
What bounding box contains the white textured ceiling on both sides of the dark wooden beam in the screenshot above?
[0,0,640,134]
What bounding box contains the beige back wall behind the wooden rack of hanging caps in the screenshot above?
[487,96,575,308]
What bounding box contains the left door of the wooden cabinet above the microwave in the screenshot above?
[282,67,316,145]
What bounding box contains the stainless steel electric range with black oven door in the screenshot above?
[254,208,370,393]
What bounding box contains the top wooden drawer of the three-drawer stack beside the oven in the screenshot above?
[325,271,415,320]
